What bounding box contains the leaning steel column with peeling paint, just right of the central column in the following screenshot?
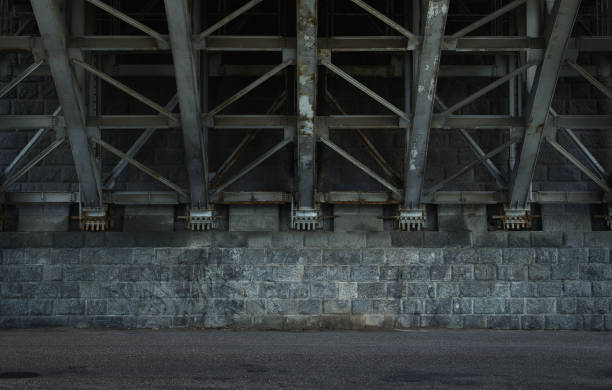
[403,0,449,209]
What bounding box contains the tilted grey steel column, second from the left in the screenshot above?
[165,0,208,209]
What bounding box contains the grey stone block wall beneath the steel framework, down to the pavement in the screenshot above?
[0,232,612,330]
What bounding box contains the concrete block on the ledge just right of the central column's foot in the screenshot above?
[334,205,384,232]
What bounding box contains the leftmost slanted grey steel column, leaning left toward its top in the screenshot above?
[31,0,102,208]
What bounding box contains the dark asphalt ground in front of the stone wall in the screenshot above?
[0,329,612,389]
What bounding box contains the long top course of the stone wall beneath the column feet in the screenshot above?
[0,231,612,248]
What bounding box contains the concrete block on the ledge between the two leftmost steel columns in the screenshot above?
[123,206,174,232]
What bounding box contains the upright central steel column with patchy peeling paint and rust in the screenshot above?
[297,0,318,209]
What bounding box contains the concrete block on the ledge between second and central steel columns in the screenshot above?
[229,205,279,232]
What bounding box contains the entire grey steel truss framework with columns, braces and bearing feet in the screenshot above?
[0,0,612,230]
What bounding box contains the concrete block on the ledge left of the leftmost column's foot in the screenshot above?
[17,205,70,232]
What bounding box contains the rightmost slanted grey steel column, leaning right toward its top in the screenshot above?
[509,0,580,209]
